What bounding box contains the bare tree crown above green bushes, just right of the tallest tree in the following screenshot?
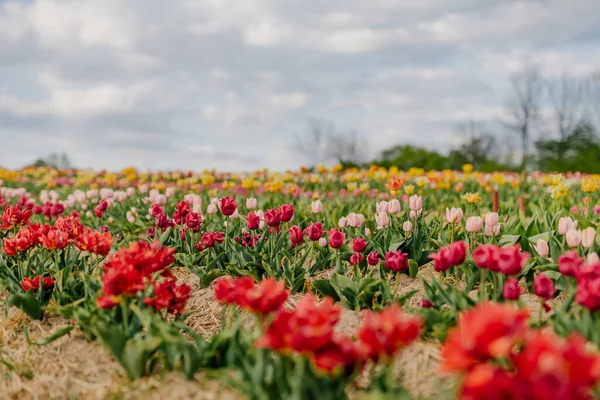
[546,75,586,140]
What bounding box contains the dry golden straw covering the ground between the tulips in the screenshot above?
[0,266,478,400]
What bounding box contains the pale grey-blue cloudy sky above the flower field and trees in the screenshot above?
[0,0,600,170]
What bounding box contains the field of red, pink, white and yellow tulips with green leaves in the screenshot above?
[0,164,600,400]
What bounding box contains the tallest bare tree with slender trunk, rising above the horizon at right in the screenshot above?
[504,67,544,168]
